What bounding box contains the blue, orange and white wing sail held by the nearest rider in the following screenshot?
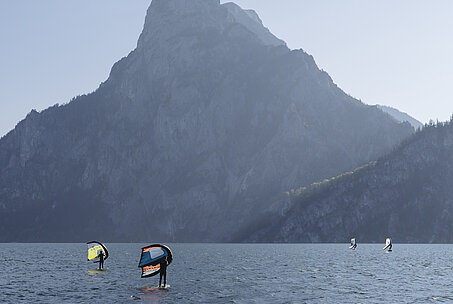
[138,244,173,278]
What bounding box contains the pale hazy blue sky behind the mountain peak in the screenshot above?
[0,0,453,136]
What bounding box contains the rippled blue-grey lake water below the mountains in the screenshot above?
[0,243,453,303]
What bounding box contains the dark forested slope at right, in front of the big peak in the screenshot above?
[247,120,453,243]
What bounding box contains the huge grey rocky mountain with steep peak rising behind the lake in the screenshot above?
[0,0,413,241]
